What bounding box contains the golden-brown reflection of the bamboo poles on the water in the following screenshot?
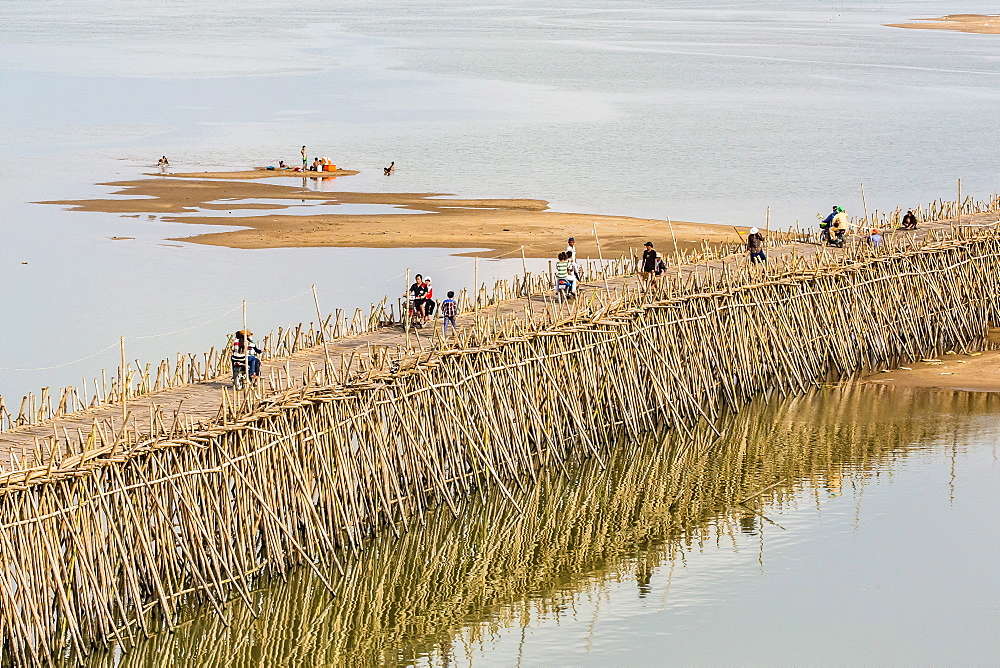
[89,387,1000,666]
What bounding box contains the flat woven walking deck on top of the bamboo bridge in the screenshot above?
[0,213,984,470]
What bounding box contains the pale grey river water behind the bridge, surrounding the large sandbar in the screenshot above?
[0,0,1000,403]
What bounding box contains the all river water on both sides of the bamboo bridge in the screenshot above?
[7,6,1000,666]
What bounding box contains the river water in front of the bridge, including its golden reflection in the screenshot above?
[80,386,1000,667]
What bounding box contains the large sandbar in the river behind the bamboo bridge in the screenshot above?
[44,175,739,258]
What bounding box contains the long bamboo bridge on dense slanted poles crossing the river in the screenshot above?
[0,196,1000,665]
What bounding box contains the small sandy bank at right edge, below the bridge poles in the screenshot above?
[860,329,1000,392]
